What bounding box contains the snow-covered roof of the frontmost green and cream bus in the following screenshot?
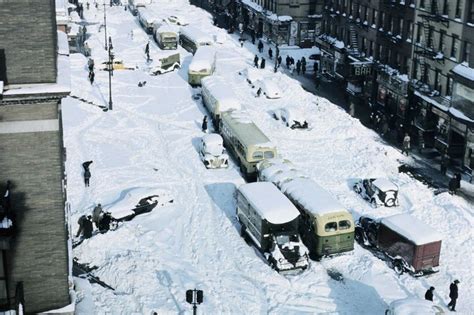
[281,178,347,216]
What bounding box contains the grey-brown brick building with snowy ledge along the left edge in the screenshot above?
[0,0,71,313]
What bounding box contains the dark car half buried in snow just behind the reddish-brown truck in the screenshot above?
[353,178,398,207]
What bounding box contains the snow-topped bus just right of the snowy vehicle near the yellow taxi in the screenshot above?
[188,46,216,86]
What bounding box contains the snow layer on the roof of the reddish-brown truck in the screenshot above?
[381,213,442,245]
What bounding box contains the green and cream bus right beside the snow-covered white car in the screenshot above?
[219,110,277,181]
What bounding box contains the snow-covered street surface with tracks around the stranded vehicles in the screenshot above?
[62,0,474,314]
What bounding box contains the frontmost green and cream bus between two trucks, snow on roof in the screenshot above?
[280,178,354,260]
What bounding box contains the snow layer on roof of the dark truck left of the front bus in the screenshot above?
[239,182,300,224]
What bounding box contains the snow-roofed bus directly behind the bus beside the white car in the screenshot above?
[201,75,241,126]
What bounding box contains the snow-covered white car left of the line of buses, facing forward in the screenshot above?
[199,133,229,168]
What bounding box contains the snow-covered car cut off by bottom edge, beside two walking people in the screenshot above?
[385,297,446,315]
